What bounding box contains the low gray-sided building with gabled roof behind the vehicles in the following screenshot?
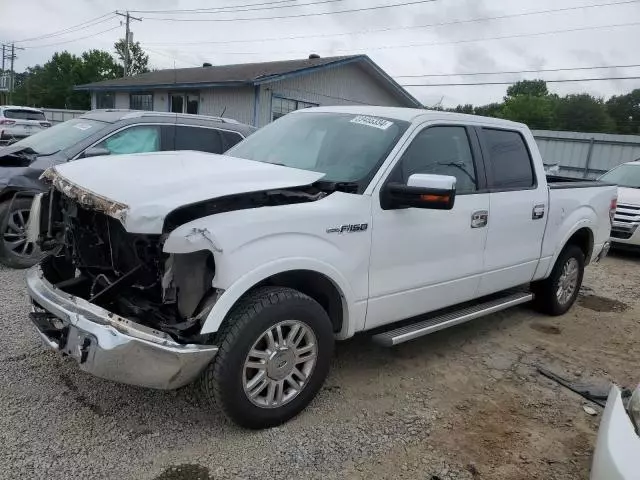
[76,55,421,127]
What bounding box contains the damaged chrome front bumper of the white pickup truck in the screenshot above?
[27,266,218,389]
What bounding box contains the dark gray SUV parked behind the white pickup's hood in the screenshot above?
[0,110,256,268]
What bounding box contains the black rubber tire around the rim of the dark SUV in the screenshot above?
[0,197,42,268]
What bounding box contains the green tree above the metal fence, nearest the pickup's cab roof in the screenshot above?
[500,94,555,130]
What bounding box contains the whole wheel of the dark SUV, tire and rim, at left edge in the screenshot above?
[0,197,41,268]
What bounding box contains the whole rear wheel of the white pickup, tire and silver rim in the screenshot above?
[532,245,584,316]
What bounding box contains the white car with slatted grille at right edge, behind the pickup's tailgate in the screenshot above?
[600,160,640,246]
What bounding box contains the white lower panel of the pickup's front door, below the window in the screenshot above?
[366,193,491,329]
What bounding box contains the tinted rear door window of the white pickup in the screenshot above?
[482,128,535,190]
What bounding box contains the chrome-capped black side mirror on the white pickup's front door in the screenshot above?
[380,173,456,210]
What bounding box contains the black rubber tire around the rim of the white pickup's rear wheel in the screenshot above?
[532,245,584,316]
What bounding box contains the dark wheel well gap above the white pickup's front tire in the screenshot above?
[254,270,344,332]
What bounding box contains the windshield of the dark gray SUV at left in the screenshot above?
[13,118,109,155]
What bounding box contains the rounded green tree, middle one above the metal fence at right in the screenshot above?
[555,93,615,133]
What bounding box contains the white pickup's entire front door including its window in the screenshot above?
[366,125,491,329]
